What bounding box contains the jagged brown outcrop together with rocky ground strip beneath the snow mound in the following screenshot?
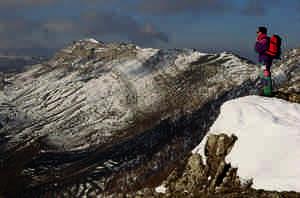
[155,134,300,198]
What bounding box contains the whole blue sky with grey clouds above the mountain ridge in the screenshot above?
[0,0,300,60]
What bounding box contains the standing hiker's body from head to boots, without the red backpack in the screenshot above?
[255,26,273,96]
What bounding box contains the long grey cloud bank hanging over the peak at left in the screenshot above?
[0,11,168,56]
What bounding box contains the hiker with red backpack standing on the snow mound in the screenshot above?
[255,26,281,96]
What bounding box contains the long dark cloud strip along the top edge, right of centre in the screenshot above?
[136,0,287,16]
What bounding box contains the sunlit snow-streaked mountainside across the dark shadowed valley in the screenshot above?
[0,39,258,149]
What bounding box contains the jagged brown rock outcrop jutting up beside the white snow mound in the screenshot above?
[161,134,240,197]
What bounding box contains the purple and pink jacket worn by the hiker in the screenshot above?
[255,34,273,67]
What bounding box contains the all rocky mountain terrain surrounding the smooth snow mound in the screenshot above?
[0,39,300,197]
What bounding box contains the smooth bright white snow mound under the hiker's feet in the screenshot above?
[193,96,300,192]
